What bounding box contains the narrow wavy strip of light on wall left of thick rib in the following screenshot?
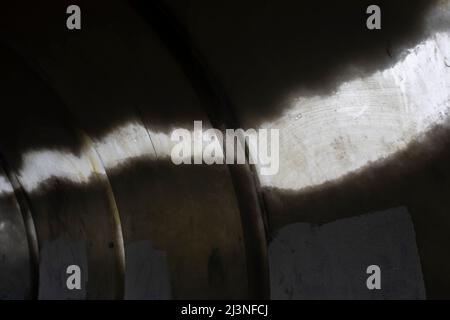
[15,122,221,194]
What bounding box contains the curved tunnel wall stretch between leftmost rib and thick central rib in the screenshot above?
[2,2,264,299]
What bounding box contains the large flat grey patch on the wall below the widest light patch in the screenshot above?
[269,207,425,299]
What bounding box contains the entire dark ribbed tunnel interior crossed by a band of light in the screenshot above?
[0,0,450,300]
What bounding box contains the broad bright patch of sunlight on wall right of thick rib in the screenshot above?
[260,33,450,189]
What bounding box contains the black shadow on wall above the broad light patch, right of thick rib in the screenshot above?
[164,0,449,127]
